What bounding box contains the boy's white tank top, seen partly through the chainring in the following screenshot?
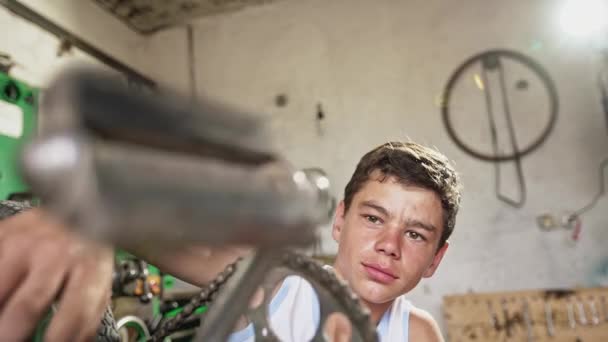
[228,276,413,342]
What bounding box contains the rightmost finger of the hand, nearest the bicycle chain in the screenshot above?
[47,263,110,341]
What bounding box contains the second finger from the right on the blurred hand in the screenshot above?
[0,248,67,341]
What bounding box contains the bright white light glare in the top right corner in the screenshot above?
[560,0,608,37]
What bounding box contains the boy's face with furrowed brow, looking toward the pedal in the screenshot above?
[332,172,447,304]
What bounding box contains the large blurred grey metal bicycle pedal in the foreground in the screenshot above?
[23,70,331,247]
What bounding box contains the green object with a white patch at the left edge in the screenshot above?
[0,72,39,201]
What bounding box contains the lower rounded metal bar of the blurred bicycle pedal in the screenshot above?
[25,136,328,245]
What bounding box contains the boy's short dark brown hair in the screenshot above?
[344,142,461,248]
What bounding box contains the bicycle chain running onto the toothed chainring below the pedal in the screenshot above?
[152,251,378,342]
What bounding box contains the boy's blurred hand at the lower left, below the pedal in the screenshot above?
[0,209,114,341]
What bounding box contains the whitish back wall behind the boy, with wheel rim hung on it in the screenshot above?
[182,0,608,334]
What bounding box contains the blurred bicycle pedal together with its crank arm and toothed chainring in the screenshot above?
[23,70,377,341]
